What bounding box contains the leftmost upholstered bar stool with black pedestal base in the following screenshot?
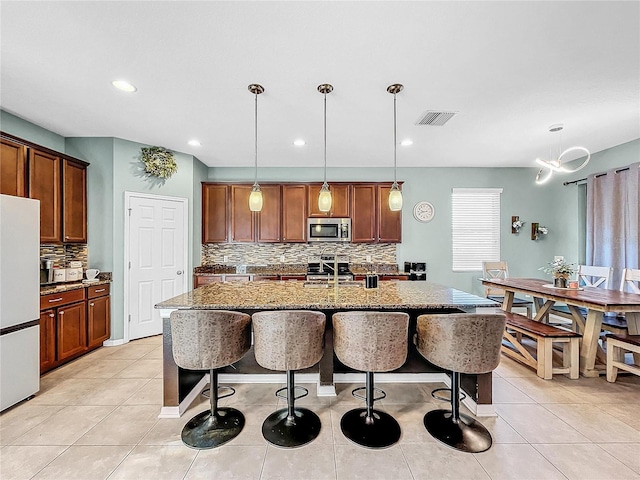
[170,310,251,449]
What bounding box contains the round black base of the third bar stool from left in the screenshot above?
[340,408,400,448]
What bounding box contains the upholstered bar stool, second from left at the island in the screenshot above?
[252,310,326,447]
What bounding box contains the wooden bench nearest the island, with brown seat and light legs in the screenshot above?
[501,312,581,380]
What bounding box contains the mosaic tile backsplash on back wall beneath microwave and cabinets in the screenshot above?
[201,243,396,265]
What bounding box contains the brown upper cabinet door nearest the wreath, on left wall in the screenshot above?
[62,158,87,243]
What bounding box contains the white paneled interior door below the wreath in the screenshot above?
[127,194,188,340]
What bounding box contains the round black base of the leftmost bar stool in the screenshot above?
[182,407,245,450]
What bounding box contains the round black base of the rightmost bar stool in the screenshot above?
[424,410,492,453]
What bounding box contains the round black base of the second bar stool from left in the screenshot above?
[262,407,320,448]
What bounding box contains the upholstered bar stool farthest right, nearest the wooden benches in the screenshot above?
[417,313,506,453]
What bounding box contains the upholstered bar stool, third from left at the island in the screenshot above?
[332,312,409,448]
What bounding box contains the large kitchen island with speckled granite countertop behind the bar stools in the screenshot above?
[156,281,499,417]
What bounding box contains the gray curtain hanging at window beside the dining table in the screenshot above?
[586,163,640,290]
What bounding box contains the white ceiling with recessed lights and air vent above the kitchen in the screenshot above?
[0,0,640,167]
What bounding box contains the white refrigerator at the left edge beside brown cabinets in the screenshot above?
[0,195,40,411]
